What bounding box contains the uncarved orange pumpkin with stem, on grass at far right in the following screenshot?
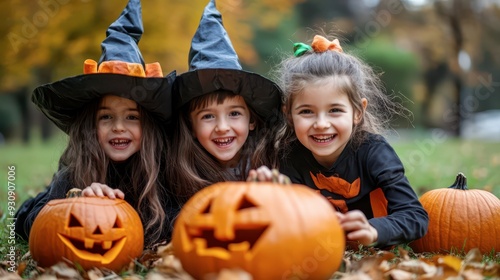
[410,173,500,254]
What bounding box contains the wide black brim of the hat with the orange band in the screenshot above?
[31,72,175,133]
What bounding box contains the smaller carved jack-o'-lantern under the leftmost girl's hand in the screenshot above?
[29,191,144,271]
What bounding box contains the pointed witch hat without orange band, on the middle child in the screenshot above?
[173,0,282,119]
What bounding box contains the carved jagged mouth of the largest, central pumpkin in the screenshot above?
[191,226,268,251]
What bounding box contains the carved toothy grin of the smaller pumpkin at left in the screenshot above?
[58,234,126,264]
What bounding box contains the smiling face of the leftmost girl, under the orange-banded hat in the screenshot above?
[97,95,142,162]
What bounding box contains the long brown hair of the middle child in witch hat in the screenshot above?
[167,91,280,203]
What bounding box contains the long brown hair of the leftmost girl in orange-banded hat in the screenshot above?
[61,97,169,245]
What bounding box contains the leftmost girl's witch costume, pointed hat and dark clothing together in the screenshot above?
[15,0,180,247]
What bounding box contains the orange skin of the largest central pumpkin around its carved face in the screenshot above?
[172,182,345,279]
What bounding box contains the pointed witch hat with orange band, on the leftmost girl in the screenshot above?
[31,0,175,133]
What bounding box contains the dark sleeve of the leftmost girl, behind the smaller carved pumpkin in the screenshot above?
[15,173,70,241]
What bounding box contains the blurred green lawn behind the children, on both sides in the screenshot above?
[0,131,500,212]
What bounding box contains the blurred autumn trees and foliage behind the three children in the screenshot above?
[0,0,500,206]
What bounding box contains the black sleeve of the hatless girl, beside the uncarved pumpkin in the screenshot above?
[366,141,429,247]
